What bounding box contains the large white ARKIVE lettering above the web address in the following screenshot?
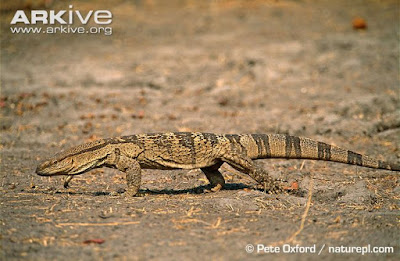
[10,5,112,25]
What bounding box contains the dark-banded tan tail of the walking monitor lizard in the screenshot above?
[247,134,400,171]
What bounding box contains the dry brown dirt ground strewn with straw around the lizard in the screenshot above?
[0,0,400,260]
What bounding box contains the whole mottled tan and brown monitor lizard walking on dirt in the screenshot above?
[36,132,400,196]
